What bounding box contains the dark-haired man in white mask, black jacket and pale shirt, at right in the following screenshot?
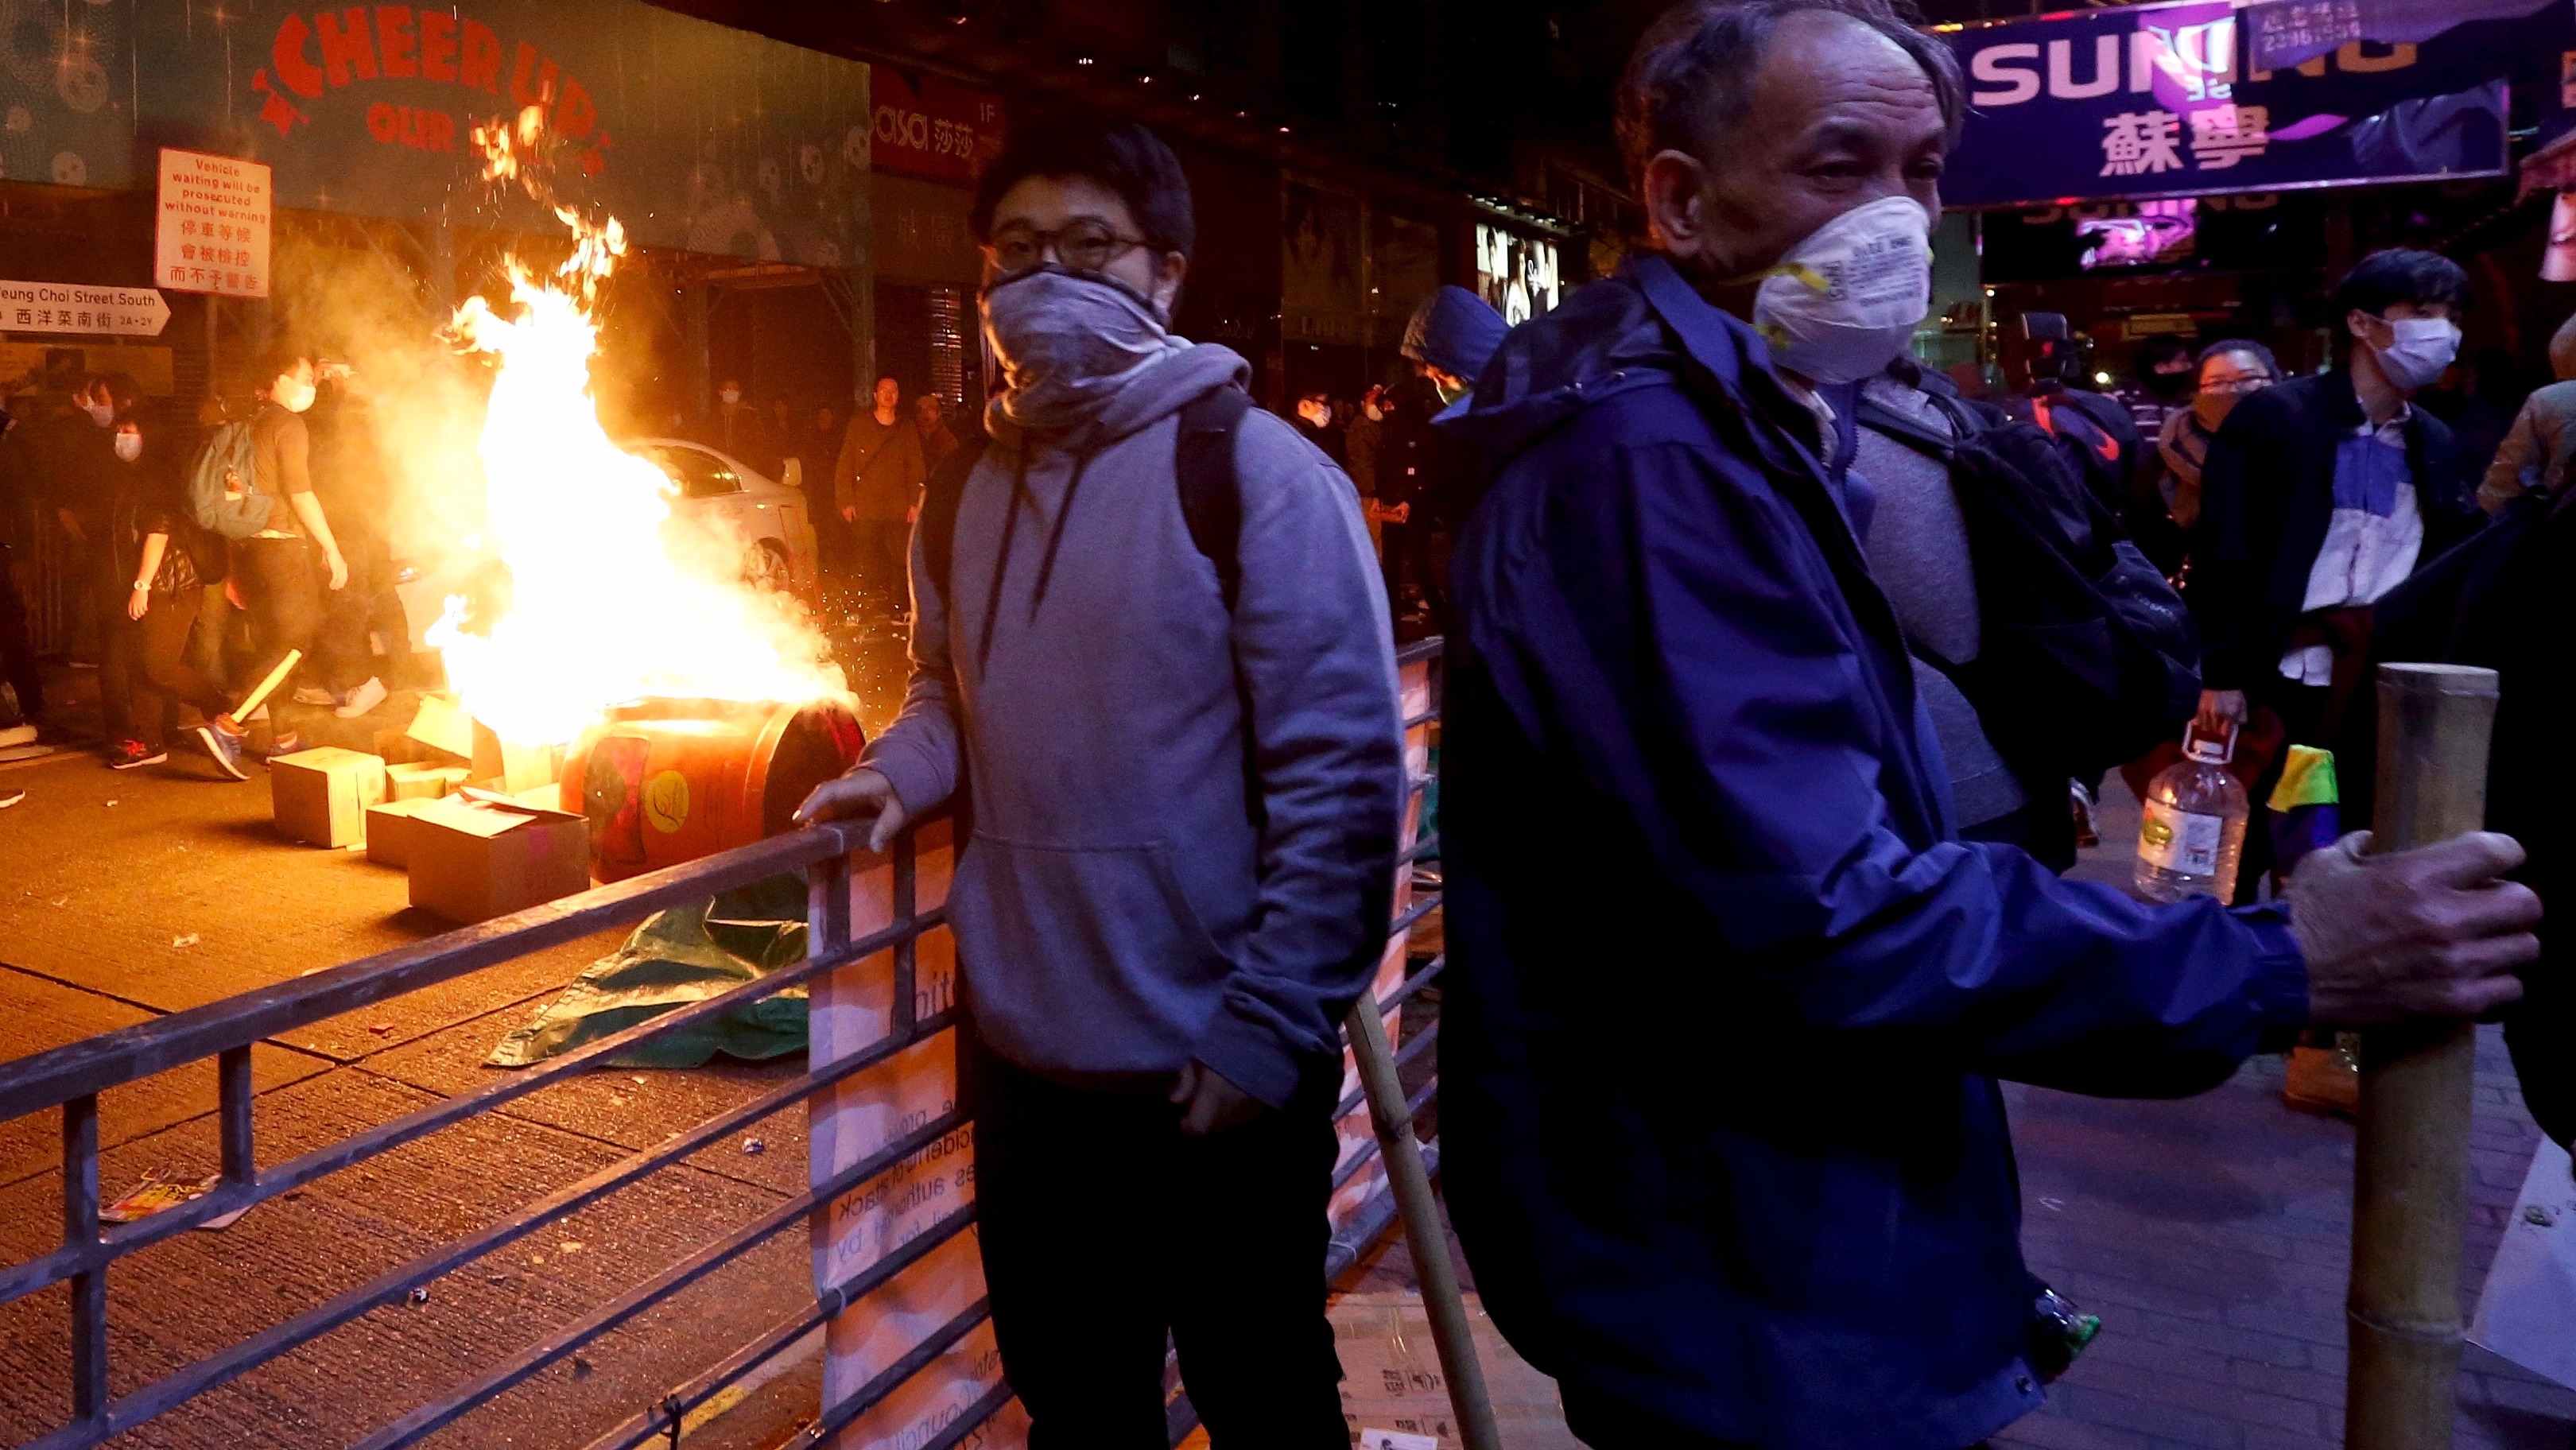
[2185,247,2486,896]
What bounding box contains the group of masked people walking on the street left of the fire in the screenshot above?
[0,347,409,781]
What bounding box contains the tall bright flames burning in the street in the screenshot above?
[428,108,845,744]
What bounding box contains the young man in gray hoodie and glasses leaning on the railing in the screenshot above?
[801,118,1404,1450]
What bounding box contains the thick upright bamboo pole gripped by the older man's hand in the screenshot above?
[2344,665,2496,1450]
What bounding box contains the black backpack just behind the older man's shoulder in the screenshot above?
[1857,394,2200,781]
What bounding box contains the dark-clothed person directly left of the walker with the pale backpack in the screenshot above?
[98,412,232,770]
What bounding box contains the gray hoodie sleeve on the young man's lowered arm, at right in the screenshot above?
[1189,412,1404,1107]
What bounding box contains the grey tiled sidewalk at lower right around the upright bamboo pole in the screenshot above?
[1996,1028,2576,1450]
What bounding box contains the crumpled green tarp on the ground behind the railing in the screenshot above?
[484,876,806,1066]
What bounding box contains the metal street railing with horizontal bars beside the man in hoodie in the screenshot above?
[0,642,1445,1450]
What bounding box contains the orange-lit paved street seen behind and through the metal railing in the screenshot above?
[0,674,812,1450]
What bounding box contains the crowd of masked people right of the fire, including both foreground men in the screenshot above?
[801,0,2566,1450]
